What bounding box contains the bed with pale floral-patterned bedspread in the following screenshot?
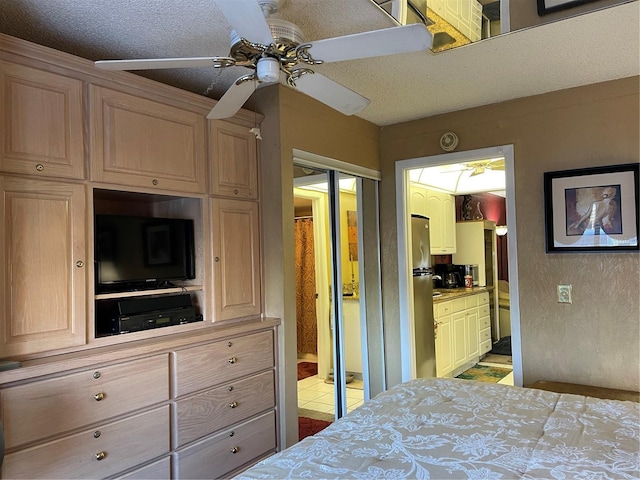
[237,379,640,479]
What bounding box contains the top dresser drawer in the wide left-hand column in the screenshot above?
[0,354,169,448]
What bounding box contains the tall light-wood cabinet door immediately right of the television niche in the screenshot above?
[211,199,261,322]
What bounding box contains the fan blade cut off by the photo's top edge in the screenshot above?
[214,0,273,45]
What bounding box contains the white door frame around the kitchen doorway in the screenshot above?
[395,145,523,386]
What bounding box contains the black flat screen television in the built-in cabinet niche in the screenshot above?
[94,215,195,293]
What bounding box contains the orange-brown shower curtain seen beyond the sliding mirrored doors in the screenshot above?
[295,218,318,355]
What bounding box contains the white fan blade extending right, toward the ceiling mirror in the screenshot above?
[309,23,432,62]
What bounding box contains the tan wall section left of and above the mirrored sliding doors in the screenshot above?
[255,85,380,446]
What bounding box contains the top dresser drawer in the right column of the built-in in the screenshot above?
[175,331,274,396]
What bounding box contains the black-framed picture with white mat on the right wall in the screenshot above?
[544,163,639,253]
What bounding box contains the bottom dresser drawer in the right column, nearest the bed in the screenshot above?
[176,412,276,478]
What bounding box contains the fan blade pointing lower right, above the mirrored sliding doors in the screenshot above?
[295,73,371,115]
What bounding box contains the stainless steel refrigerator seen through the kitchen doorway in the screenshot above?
[411,214,436,378]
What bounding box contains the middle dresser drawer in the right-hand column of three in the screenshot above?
[176,371,275,447]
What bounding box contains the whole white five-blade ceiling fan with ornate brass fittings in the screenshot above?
[95,0,432,119]
